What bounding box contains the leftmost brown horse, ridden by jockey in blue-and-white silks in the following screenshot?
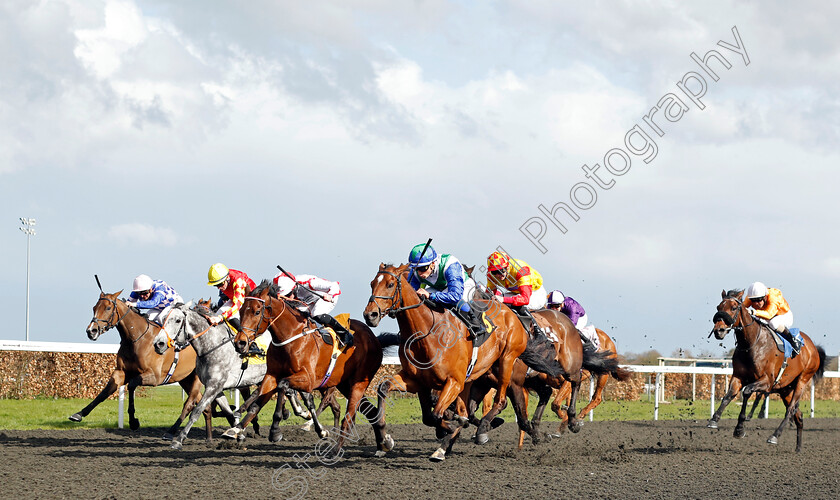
[77,290,223,439]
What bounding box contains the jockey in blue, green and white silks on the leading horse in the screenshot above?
[408,243,487,339]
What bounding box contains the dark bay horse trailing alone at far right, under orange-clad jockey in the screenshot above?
[708,290,825,451]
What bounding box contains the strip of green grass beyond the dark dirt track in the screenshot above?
[0,387,840,430]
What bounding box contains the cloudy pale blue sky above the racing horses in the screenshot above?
[0,0,840,360]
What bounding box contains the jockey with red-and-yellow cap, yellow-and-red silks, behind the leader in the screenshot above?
[487,252,547,331]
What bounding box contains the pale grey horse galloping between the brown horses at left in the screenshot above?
[154,305,283,450]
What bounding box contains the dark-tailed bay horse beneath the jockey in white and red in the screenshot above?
[223,280,382,456]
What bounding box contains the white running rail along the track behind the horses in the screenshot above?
[0,340,840,428]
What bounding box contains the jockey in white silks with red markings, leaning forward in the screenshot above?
[274,271,353,349]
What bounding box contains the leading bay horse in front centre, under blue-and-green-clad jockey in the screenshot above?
[364,264,562,461]
